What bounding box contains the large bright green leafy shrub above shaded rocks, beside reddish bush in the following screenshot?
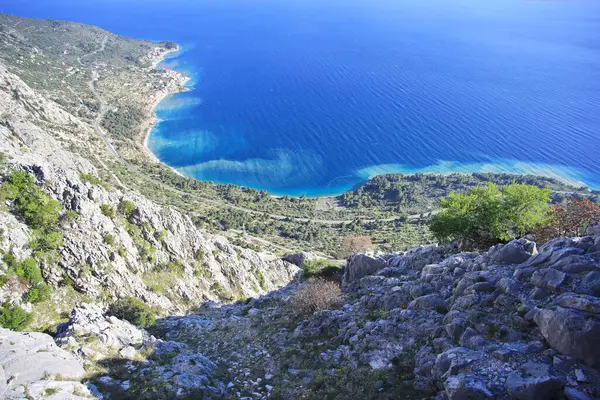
[429,183,550,247]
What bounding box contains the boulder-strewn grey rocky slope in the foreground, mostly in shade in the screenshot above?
[0,236,600,400]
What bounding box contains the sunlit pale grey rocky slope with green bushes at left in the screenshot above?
[0,66,297,327]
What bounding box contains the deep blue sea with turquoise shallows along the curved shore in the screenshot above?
[0,0,600,195]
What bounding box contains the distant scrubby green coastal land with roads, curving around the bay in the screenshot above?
[0,14,436,254]
